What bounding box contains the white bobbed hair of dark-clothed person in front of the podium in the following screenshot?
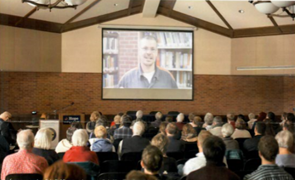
[34,128,53,150]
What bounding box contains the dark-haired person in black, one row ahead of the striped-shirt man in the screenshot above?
[243,122,266,152]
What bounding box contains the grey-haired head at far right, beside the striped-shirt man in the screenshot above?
[276,131,294,151]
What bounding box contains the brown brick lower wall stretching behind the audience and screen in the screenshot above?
[0,72,295,114]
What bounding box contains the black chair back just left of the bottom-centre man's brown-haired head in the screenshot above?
[101,160,138,173]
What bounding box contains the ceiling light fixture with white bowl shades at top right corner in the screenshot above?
[249,0,295,21]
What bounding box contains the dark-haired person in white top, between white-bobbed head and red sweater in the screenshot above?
[55,121,83,153]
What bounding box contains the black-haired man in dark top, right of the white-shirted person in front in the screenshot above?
[187,136,240,180]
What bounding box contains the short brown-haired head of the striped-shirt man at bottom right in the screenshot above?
[258,136,279,162]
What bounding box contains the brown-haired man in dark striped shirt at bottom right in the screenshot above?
[244,136,293,180]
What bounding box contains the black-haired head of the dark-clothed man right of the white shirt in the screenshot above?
[203,136,226,163]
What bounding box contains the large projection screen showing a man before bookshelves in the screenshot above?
[102,28,194,100]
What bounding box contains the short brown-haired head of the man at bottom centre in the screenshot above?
[142,145,163,172]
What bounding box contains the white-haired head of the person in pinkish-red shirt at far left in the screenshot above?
[17,129,34,150]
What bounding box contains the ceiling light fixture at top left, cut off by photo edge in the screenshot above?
[22,0,86,11]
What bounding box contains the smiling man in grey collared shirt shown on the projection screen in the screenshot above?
[118,36,178,89]
